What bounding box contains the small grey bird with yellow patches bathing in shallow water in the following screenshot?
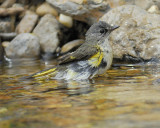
[29,21,119,80]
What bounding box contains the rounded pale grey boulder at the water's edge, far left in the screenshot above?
[5,33,40,59]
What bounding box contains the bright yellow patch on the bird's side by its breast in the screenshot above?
[88,48,103,67]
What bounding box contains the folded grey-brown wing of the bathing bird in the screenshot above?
[58,45,98,64]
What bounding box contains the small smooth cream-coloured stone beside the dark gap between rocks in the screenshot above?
[59,14,73,28]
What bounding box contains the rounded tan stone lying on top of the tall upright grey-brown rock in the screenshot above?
[36,2,58,16]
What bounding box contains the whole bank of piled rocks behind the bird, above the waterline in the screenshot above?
[0,0,160,62]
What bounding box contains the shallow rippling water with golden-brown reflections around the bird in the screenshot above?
[0,61,160,128]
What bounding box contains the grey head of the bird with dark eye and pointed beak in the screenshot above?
[86,21,119,41]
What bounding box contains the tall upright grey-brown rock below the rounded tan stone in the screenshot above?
[33,14,60,53]
